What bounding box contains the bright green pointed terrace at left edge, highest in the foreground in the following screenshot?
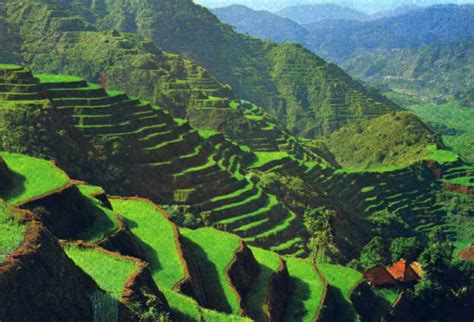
[0,152,69,205]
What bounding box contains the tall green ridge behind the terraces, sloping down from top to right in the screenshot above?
[0,0,397,136]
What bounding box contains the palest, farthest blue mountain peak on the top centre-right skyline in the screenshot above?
[275,4,370,25]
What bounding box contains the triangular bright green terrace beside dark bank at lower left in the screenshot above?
[64,245,138,301]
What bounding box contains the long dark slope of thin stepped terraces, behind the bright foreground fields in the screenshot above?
[0,67,308,254]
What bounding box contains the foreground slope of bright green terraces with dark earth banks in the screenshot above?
[0,148,366,321]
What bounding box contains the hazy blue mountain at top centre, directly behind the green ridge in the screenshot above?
[212,5,307,43]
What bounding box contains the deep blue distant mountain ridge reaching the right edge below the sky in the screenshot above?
[305,5,474,63]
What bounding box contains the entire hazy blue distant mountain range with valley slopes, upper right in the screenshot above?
[214,5,474,105]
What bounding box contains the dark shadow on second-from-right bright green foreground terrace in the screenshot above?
[285,277,312,321]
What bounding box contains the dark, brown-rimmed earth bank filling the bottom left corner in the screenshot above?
[0,220,96,322]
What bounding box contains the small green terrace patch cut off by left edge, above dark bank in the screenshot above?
[0,203,25,263]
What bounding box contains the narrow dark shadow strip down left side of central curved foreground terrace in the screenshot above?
[183,238,232,313]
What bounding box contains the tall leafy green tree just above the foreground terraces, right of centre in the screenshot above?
[304,207,336,262]
